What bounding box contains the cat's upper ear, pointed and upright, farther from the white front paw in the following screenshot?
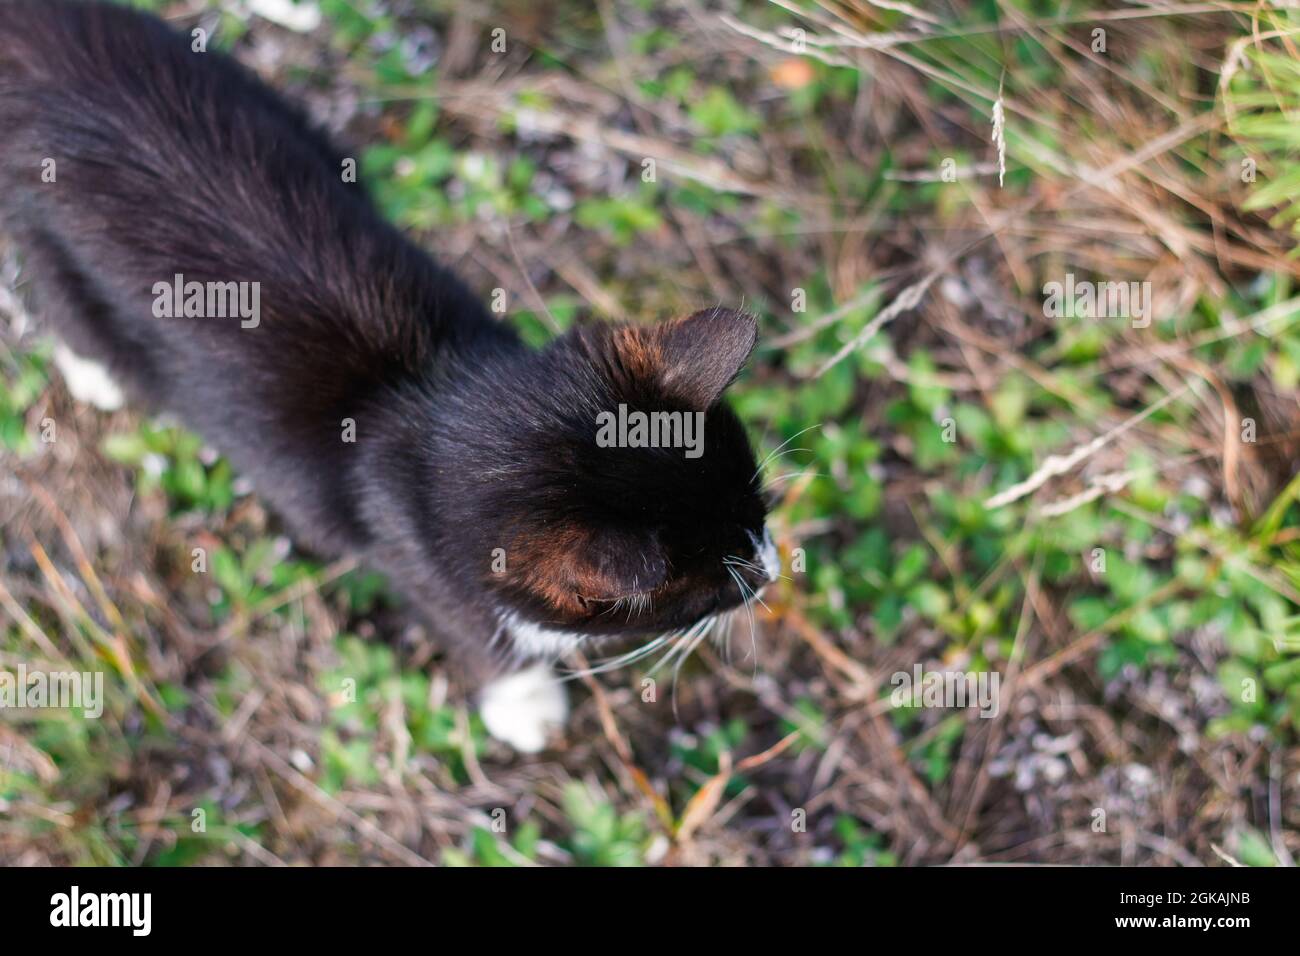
[655,308,758,410]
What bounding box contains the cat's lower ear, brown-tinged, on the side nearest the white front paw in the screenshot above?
[562,528,668,606]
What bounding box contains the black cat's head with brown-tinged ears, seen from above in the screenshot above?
[467,308,779,635]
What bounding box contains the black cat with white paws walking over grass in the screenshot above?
[0,0,777,750]
